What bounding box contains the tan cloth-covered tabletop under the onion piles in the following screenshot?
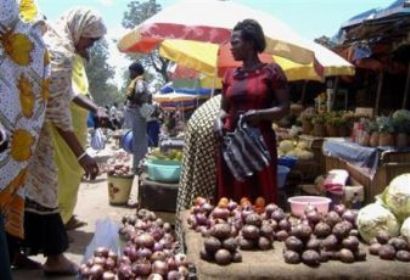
[180,211,410,280]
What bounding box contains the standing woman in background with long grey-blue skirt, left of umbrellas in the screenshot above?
[124,62,152,174]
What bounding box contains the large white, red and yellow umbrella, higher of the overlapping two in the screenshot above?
[118,0,315,71]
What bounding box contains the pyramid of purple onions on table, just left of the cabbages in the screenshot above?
[283,205,366,266]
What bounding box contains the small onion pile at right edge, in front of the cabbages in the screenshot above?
[369,230,410,262]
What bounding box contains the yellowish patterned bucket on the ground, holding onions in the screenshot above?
[107,175,134,205]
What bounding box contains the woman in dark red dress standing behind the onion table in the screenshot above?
[217,19,289,202]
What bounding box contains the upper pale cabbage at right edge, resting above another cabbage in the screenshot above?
[382,173,410,221]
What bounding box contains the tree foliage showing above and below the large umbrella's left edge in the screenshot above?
[122,0,169,82]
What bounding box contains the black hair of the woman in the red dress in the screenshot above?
[233,19,266,53]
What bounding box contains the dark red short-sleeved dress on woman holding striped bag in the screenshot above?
[217,64,287,202]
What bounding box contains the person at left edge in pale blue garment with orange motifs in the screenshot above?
[0,0,49,280]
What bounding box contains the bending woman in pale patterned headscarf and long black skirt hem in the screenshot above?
[7,8,106,275]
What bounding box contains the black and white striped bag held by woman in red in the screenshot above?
[222,117,271,182]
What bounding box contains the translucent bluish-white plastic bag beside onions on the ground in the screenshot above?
[83,218,120,263]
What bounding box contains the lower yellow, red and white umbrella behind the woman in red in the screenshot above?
[160,40,355,81]
